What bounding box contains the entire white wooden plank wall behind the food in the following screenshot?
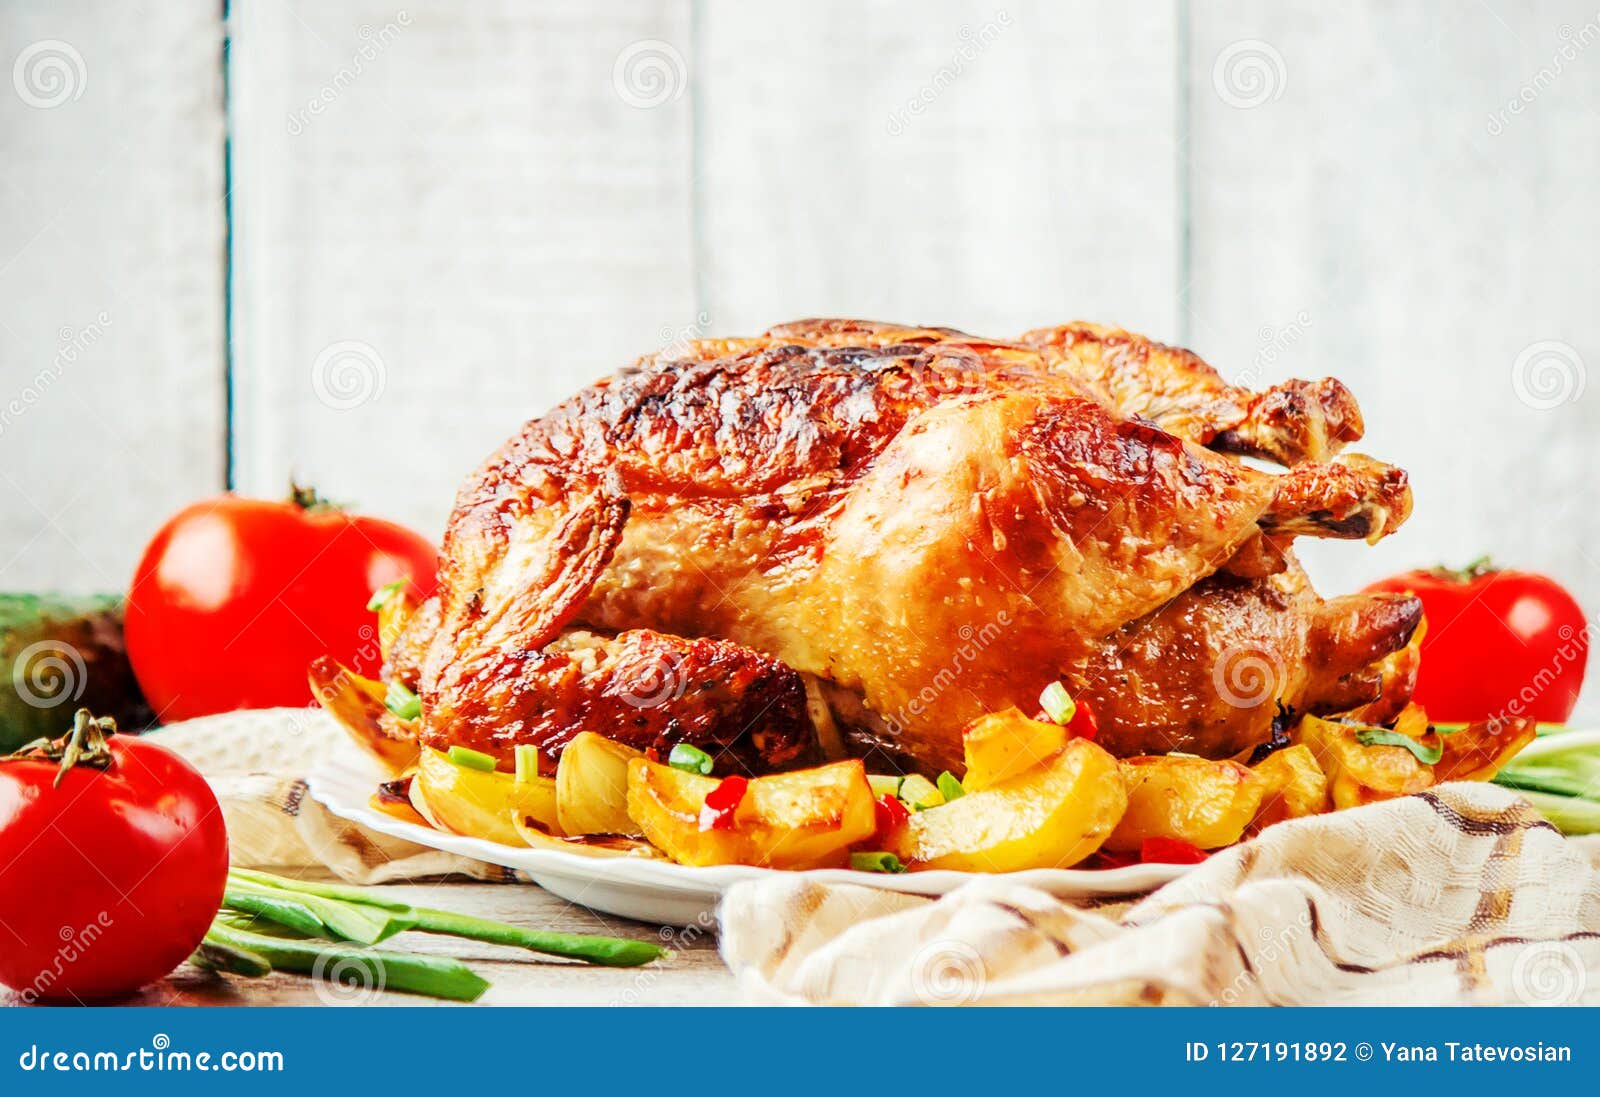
[0,0,1600,729]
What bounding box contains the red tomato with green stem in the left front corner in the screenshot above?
[0,712,227,1003]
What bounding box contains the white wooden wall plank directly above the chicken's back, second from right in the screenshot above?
[694,0,1181,336]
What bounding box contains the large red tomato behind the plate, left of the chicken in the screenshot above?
[125,489,437,721]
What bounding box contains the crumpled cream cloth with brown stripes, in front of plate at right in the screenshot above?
[720,784,1600,1006]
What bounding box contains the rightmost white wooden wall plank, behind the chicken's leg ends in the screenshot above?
[1186,0,1600,718]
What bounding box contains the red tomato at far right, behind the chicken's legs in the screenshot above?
[1368,561,1589,723]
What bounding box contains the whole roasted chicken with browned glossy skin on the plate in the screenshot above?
[387,320,1421,772]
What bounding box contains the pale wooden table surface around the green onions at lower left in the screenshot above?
[0,883,738,1006]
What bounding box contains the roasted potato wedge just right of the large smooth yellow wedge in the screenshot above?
[1106,755,1272,849]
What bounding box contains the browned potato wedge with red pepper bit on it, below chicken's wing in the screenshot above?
[627,758,875,868]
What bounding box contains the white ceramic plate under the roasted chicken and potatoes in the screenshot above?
[307,744,1186,926]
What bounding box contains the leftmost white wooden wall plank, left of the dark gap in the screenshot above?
[0,0,227,590]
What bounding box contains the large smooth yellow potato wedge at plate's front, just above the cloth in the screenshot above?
[888,739,1128,872]
